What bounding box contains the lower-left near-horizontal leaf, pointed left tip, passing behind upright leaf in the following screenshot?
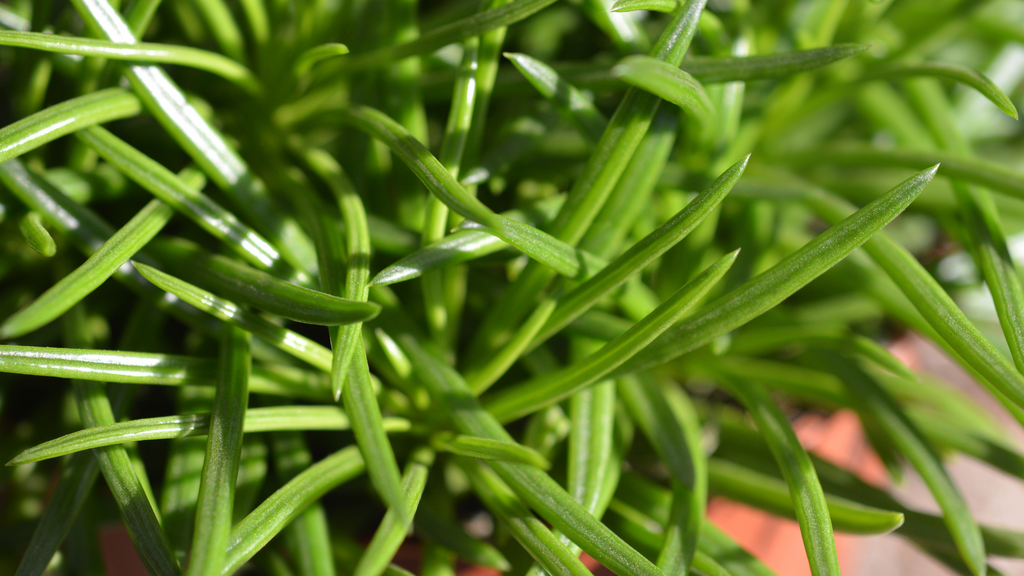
[7,406,410,465]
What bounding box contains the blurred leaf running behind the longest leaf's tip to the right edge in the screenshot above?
[808,192,1024,407]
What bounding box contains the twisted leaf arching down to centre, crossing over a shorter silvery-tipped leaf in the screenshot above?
[341,106,581,277]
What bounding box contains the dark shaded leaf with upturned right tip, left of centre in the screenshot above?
[152,241,380,326]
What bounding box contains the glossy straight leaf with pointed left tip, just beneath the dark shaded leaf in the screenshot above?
[132,262,331,372]
